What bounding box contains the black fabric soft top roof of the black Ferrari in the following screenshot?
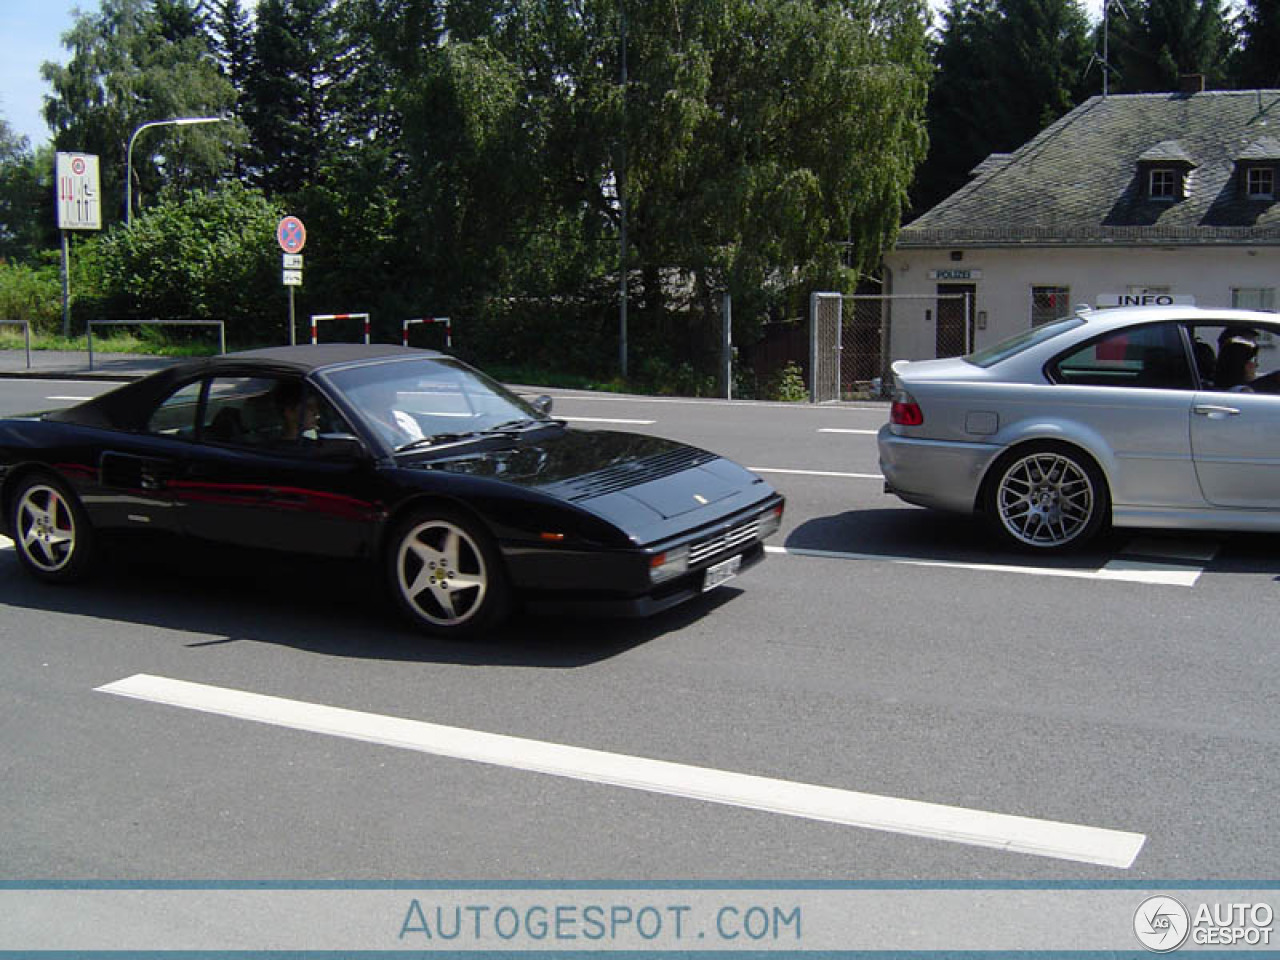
[46,343,447,430]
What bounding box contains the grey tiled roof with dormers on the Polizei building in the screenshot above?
[897,90,1280,248]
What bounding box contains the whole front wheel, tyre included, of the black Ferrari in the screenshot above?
[387,511,508,637]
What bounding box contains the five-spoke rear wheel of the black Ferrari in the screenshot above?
[9,474,93,584]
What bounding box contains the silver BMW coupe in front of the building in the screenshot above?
[878,306,1280,552]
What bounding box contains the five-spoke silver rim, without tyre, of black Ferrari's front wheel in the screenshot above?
[394,517,497,632]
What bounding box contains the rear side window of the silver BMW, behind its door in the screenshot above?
[1050,324,1196,390]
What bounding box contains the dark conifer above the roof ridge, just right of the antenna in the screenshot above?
[1108,0,1233,93]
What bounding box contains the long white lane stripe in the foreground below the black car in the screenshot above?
[97,673,1147,869]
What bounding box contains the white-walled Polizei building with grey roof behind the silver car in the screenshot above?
[884,90,1280,360]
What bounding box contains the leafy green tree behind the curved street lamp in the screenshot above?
[41,0,236,225]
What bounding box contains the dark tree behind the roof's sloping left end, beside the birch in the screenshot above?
[913,0,1092,211]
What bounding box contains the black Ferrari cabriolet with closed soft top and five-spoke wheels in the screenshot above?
[0,344,783,635]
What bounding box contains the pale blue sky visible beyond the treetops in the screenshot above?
[0,0,1102,147]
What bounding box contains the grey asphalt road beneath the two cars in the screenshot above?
[0,380,1280,882]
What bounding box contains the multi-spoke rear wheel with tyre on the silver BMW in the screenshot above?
[986,442,1108,552]
